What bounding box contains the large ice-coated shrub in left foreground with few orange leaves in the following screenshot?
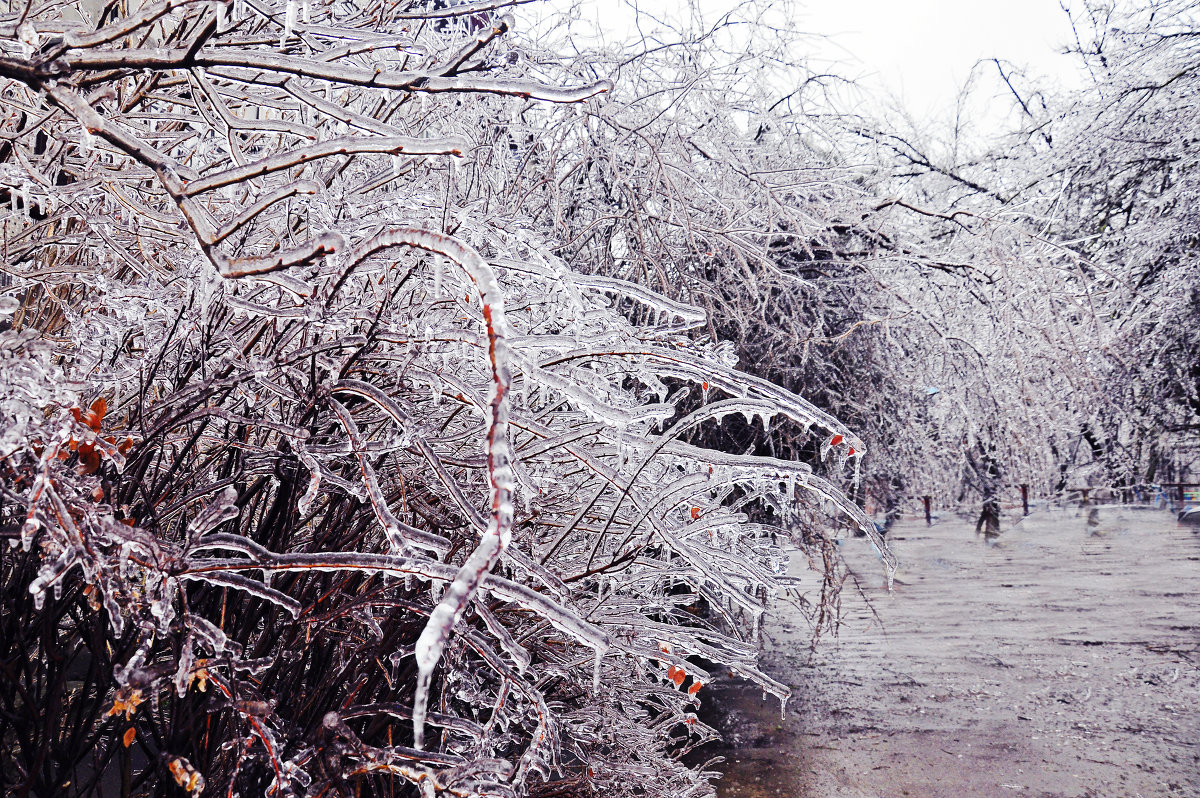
[0,0,874,796]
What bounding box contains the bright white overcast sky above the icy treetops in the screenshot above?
[540,0,1081,127]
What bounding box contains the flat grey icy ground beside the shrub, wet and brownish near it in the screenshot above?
[706,508,1200,798]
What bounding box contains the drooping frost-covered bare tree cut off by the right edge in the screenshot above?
[1038,1,1200,484]
